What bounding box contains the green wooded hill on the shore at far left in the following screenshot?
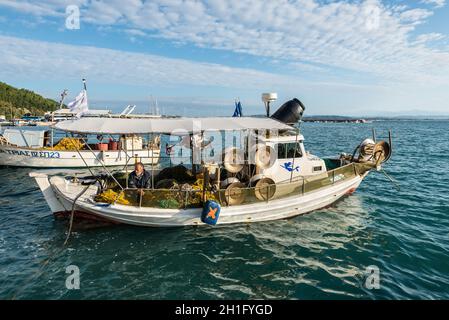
[0,82,59,119]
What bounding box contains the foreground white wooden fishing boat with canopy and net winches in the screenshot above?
[30,94,392,227]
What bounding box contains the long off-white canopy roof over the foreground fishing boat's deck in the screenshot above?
[54,117,292,135]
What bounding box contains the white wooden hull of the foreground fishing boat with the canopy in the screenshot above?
[32,173,367,227]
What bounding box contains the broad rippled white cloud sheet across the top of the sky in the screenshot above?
[0,0,449,85]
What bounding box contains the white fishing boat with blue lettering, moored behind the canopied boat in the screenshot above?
[0,127,160,168]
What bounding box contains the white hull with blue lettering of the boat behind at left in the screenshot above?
[0,145,160,168]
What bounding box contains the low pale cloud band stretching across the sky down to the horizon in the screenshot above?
[0,35,449,114]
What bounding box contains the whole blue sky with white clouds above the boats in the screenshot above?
[0,0,449,115]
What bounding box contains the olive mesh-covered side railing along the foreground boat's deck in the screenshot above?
[109,163,366,209]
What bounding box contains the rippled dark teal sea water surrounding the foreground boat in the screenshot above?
[0,121,449,299]
